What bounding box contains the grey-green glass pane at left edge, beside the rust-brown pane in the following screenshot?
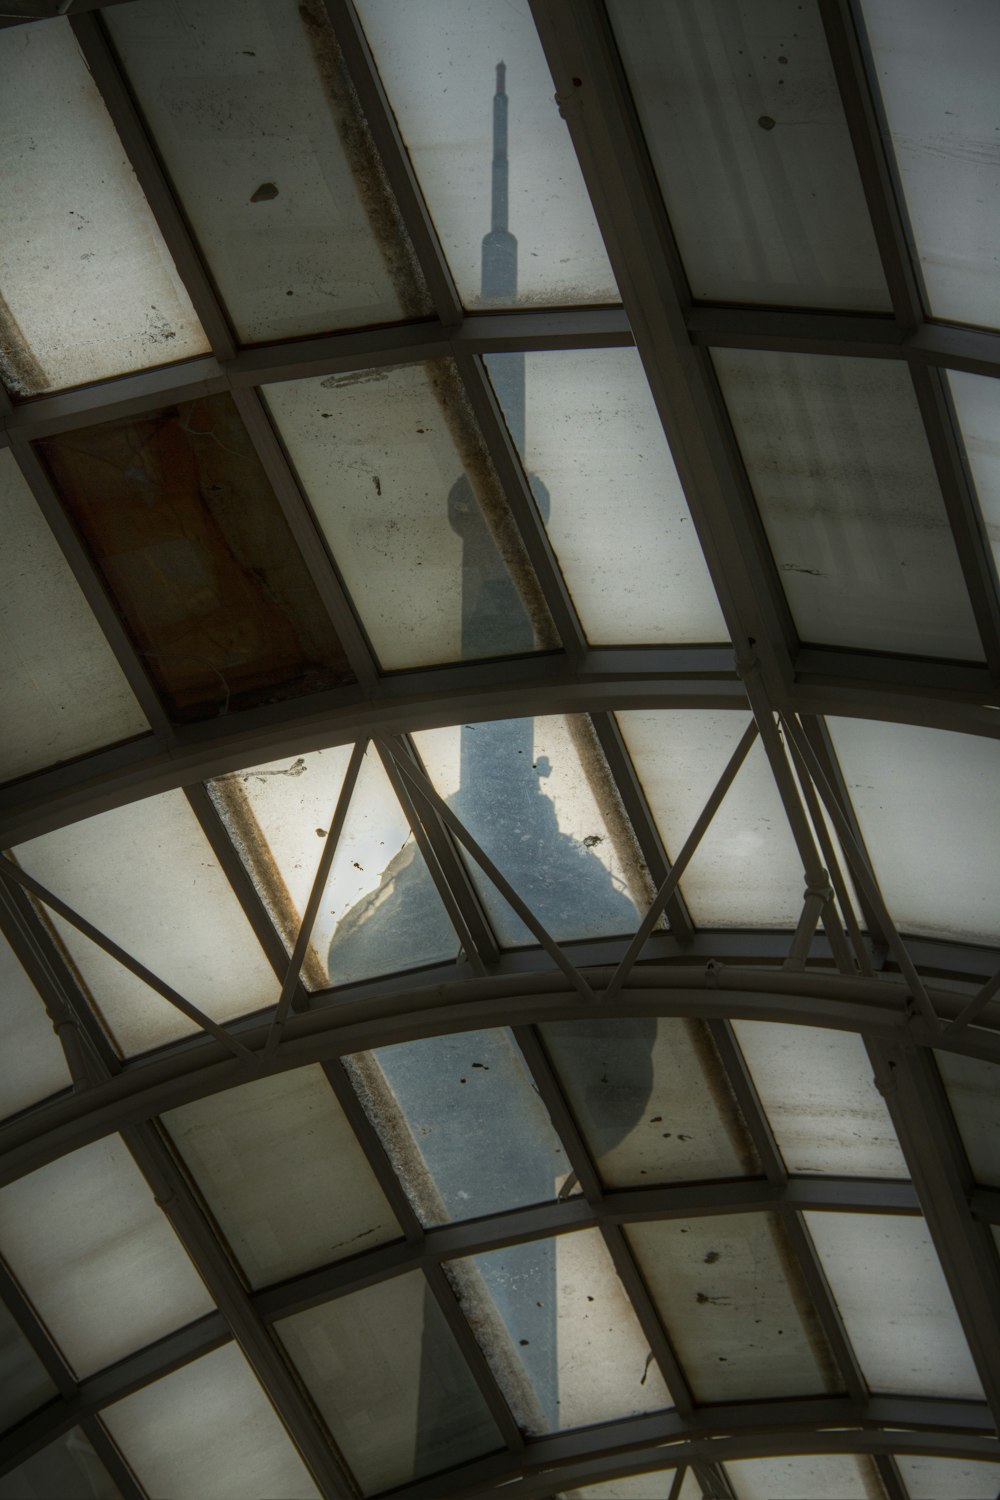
[0,447,148,782]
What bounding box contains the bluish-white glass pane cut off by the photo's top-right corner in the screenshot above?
[862,0,1000,326]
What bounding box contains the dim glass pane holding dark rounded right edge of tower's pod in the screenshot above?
[543,1017,757,1188]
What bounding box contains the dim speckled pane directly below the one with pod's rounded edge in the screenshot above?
[625,1214,838,1401]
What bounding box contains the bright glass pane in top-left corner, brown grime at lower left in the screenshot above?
[0,21,208,396]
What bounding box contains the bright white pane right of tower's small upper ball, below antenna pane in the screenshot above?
[486,350,727,645]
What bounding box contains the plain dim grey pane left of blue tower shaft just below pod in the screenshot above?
[163,1067,402,1287]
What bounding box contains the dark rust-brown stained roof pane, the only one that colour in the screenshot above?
[37,395,354,722]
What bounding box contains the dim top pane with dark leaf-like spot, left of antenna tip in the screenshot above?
[108,0,430,342]
